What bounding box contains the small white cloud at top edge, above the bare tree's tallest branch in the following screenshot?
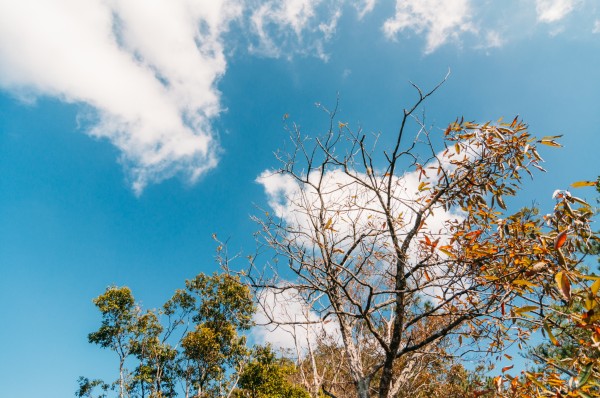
[383,0,476,53]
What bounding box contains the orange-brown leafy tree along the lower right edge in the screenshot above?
[512,180,600,397]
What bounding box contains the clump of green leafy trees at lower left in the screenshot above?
[81,273,254,398]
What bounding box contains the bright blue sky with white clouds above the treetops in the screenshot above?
[0,0,600,398]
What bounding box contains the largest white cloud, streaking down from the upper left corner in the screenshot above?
[0,0,241,193]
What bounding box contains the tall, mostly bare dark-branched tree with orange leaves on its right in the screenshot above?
[248,79,583,398]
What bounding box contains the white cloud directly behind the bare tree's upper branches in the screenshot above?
[257,151,464,268]
